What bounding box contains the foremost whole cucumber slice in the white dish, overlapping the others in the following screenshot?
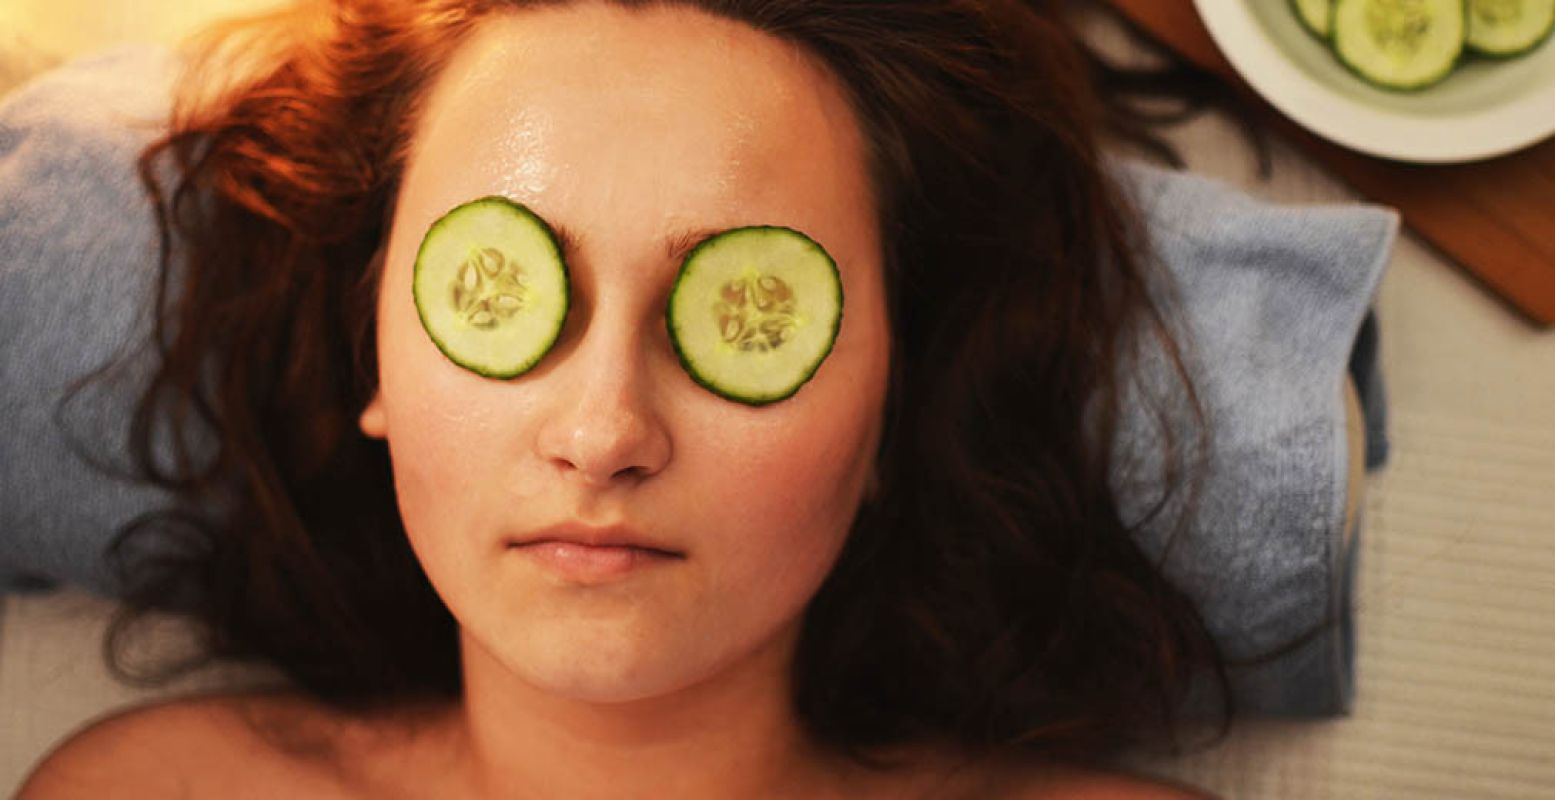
[1333,0,1468,90]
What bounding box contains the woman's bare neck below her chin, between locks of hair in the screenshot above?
[444,627,858,798]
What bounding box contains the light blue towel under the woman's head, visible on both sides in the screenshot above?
[0,47,1396,714]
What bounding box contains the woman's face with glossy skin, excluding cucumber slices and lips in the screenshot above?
[361,3,889,702]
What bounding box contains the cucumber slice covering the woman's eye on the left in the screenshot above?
[412,196,569,378]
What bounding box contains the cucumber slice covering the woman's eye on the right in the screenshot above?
[666,226,843,406]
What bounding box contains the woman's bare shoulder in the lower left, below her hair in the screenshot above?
[19,693,356,800]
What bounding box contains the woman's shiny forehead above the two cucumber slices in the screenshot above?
[401,3,874,255]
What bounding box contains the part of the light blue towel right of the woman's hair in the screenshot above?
[1115,162,1398,716]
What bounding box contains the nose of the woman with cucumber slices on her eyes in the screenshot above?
[536,311,670,489]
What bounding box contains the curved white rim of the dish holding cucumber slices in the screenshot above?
[1193,0,1555,163]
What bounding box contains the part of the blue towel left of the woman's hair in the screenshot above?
[0,47,185,595]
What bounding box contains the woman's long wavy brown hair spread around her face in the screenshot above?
[90,0,1262,768]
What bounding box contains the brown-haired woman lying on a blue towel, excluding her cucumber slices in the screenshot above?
[22,0,1250,798]
